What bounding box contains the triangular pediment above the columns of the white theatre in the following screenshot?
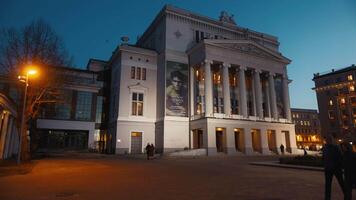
[204,39,291,63]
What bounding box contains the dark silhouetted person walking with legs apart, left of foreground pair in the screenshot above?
[323,135,345,200]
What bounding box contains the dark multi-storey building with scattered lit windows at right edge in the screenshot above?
[313,65,356,147]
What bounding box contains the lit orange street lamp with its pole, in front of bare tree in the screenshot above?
[17,66,37,164]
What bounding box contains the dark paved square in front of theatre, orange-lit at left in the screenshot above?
[0,156,356,200]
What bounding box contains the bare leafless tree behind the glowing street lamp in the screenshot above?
[0,19,72,162]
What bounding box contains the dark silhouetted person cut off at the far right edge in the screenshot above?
[341,142,356,200]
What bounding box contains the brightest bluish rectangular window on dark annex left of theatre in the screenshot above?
[75,91,92,121]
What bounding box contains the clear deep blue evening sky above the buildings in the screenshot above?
[0,0,356,108]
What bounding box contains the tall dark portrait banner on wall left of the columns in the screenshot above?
[166,61,188,117]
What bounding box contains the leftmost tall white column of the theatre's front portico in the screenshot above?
[204,60,213,117]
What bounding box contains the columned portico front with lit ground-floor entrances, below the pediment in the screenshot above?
[190,39,297,155]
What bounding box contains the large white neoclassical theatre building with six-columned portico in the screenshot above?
[108,5,296,155]
